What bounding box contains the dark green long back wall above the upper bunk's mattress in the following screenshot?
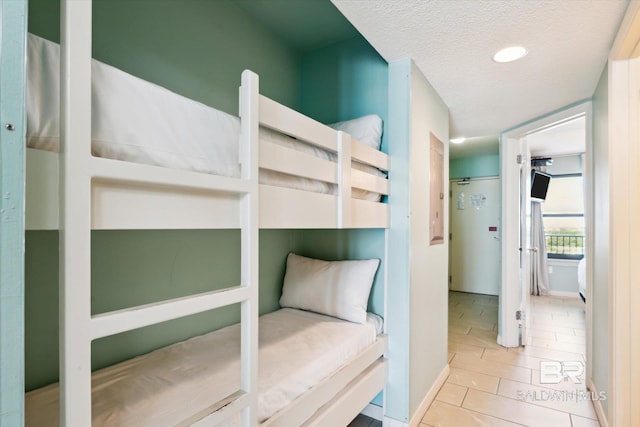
[29,0,300,114]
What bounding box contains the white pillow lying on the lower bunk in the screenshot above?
[280,253,380,323]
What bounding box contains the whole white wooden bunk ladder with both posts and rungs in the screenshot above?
[59,0,259,427]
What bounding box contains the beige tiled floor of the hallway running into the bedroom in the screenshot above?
[420,292,599,427]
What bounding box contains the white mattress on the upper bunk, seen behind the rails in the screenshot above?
[27,34,384,201]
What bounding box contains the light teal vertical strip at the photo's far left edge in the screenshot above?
[0,0,27,427]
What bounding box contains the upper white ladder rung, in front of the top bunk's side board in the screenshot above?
[89,157,251,194]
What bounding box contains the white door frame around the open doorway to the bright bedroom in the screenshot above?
[498,101,593,350]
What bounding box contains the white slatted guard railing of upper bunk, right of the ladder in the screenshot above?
[256,92,389,228]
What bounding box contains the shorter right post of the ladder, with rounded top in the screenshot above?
[240,70,260,426]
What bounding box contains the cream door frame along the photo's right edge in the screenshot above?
[603,1,640,427]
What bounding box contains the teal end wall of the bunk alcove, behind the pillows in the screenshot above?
[300,36,389,406]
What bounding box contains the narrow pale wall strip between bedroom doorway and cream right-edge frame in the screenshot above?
[591,61,609,413]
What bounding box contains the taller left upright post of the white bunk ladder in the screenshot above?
[59,0,92,427]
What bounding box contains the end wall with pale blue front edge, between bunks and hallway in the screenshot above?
[385,59,449,422]
